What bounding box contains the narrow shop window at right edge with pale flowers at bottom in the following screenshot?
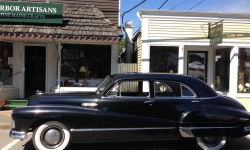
[238,48,250,93]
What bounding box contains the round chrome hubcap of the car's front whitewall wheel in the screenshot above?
[44,129,61,145]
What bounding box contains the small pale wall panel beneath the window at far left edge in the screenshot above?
[0,88,19,100]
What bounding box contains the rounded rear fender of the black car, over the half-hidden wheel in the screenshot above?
[180,106,250,137]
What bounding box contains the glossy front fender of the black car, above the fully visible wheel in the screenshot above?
[12,106,97,132]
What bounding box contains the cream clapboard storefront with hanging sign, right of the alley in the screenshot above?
[138,10,250,108]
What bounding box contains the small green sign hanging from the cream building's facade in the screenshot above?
[210,23,223,45]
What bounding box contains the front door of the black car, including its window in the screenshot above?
[94,81,154,140]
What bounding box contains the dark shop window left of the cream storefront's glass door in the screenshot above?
[150,46,179,73]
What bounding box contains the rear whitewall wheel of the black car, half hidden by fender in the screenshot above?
[196,136,227,150]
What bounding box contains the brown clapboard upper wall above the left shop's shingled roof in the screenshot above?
[11,0,119,26]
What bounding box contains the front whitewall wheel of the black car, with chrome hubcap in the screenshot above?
[32,121,70,150]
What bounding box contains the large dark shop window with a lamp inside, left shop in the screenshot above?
[61,44,111,86]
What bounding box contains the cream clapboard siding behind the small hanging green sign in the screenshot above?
[148,19,250,42]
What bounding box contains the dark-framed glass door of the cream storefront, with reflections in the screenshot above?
[187,51,207,82]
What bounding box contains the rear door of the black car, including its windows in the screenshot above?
[153,80,203,138]
